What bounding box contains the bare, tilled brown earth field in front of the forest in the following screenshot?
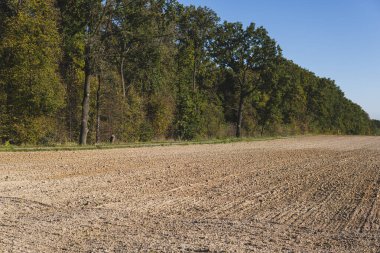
[0,136,380,253]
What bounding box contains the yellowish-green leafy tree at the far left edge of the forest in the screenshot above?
[0,0,64,143]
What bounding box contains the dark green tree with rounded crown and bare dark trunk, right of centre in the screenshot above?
[213,22,281,137]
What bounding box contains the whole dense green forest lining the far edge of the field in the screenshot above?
[0,0,380,145]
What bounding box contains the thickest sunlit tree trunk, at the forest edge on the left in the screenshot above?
[79,45,91,145]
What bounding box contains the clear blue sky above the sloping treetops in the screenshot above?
[179,0,380,120]
